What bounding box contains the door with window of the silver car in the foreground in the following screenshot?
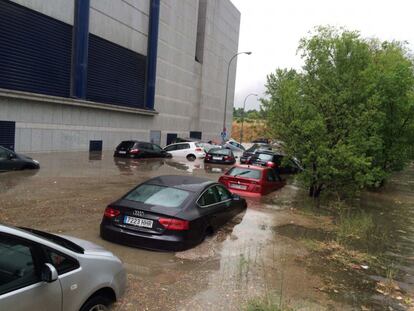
[0,233,62,311]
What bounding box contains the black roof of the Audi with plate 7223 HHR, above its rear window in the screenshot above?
[145,175,214,192]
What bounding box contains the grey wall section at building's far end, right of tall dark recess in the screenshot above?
[200,0,240,137]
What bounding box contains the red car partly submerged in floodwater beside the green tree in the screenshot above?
[219,165,285,196]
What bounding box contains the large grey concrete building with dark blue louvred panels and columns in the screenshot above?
[0,0,240,152]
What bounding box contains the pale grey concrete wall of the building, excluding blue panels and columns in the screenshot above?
[0,0,240,152]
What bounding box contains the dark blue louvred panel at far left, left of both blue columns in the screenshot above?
[0,0,72,97]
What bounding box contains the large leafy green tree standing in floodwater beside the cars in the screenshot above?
[262,27,414,198]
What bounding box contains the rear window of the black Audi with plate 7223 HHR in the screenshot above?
[125,184,190,208]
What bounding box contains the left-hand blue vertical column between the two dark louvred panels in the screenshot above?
[70,0,90,99]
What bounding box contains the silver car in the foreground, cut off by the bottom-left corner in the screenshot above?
[0,225,126,311]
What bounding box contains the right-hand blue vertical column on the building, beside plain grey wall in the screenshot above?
[145,0,160,110]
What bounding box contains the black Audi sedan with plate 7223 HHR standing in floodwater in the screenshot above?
[101,175,247,251]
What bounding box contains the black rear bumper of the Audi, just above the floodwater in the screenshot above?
[100,223,192,251]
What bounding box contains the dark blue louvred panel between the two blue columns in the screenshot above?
[86,34,146,108]
